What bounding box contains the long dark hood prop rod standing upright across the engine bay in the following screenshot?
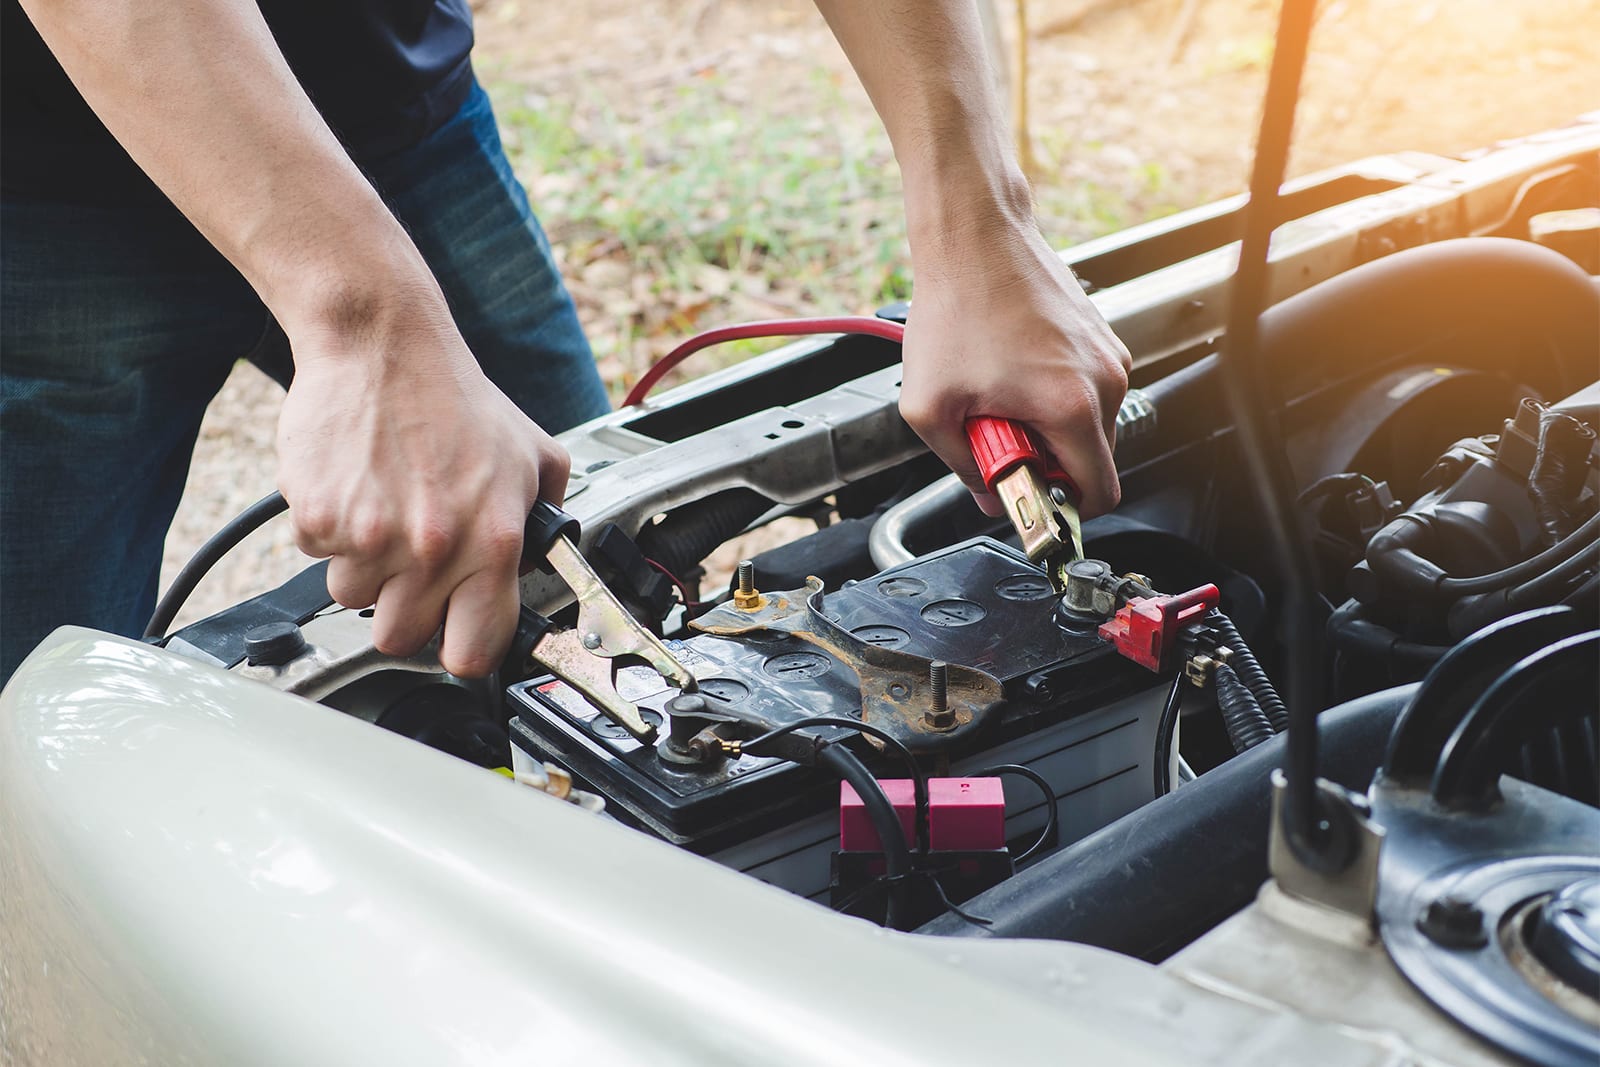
[1219,0,1331,867]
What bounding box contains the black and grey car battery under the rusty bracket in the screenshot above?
[507,537,1165,896]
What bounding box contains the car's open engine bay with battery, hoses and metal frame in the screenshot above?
[140,123,1600,1062]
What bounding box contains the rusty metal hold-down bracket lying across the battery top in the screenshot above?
[690,577,1003,752]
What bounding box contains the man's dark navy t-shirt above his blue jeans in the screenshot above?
[0,0,472,198]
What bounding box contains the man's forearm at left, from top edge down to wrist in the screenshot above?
[22,0,443,336]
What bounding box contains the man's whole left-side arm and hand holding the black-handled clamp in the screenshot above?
[22,0,568,675]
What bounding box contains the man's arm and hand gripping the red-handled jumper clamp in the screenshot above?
[816,0,1130,515]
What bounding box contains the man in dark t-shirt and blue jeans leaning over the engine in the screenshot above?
[0,0,1128,678]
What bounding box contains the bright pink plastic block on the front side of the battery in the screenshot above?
[838,777,1005,853]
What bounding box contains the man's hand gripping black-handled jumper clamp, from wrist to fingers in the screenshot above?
[278,292,570,677]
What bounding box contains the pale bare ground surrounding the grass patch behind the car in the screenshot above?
[163,0,1600,621]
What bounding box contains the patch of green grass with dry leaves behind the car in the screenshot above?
[491,69,1171,394]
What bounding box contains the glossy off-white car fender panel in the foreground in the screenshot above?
[0,629,1414,1065]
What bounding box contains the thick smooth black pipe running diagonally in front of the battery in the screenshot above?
[920,685,1416,960]
